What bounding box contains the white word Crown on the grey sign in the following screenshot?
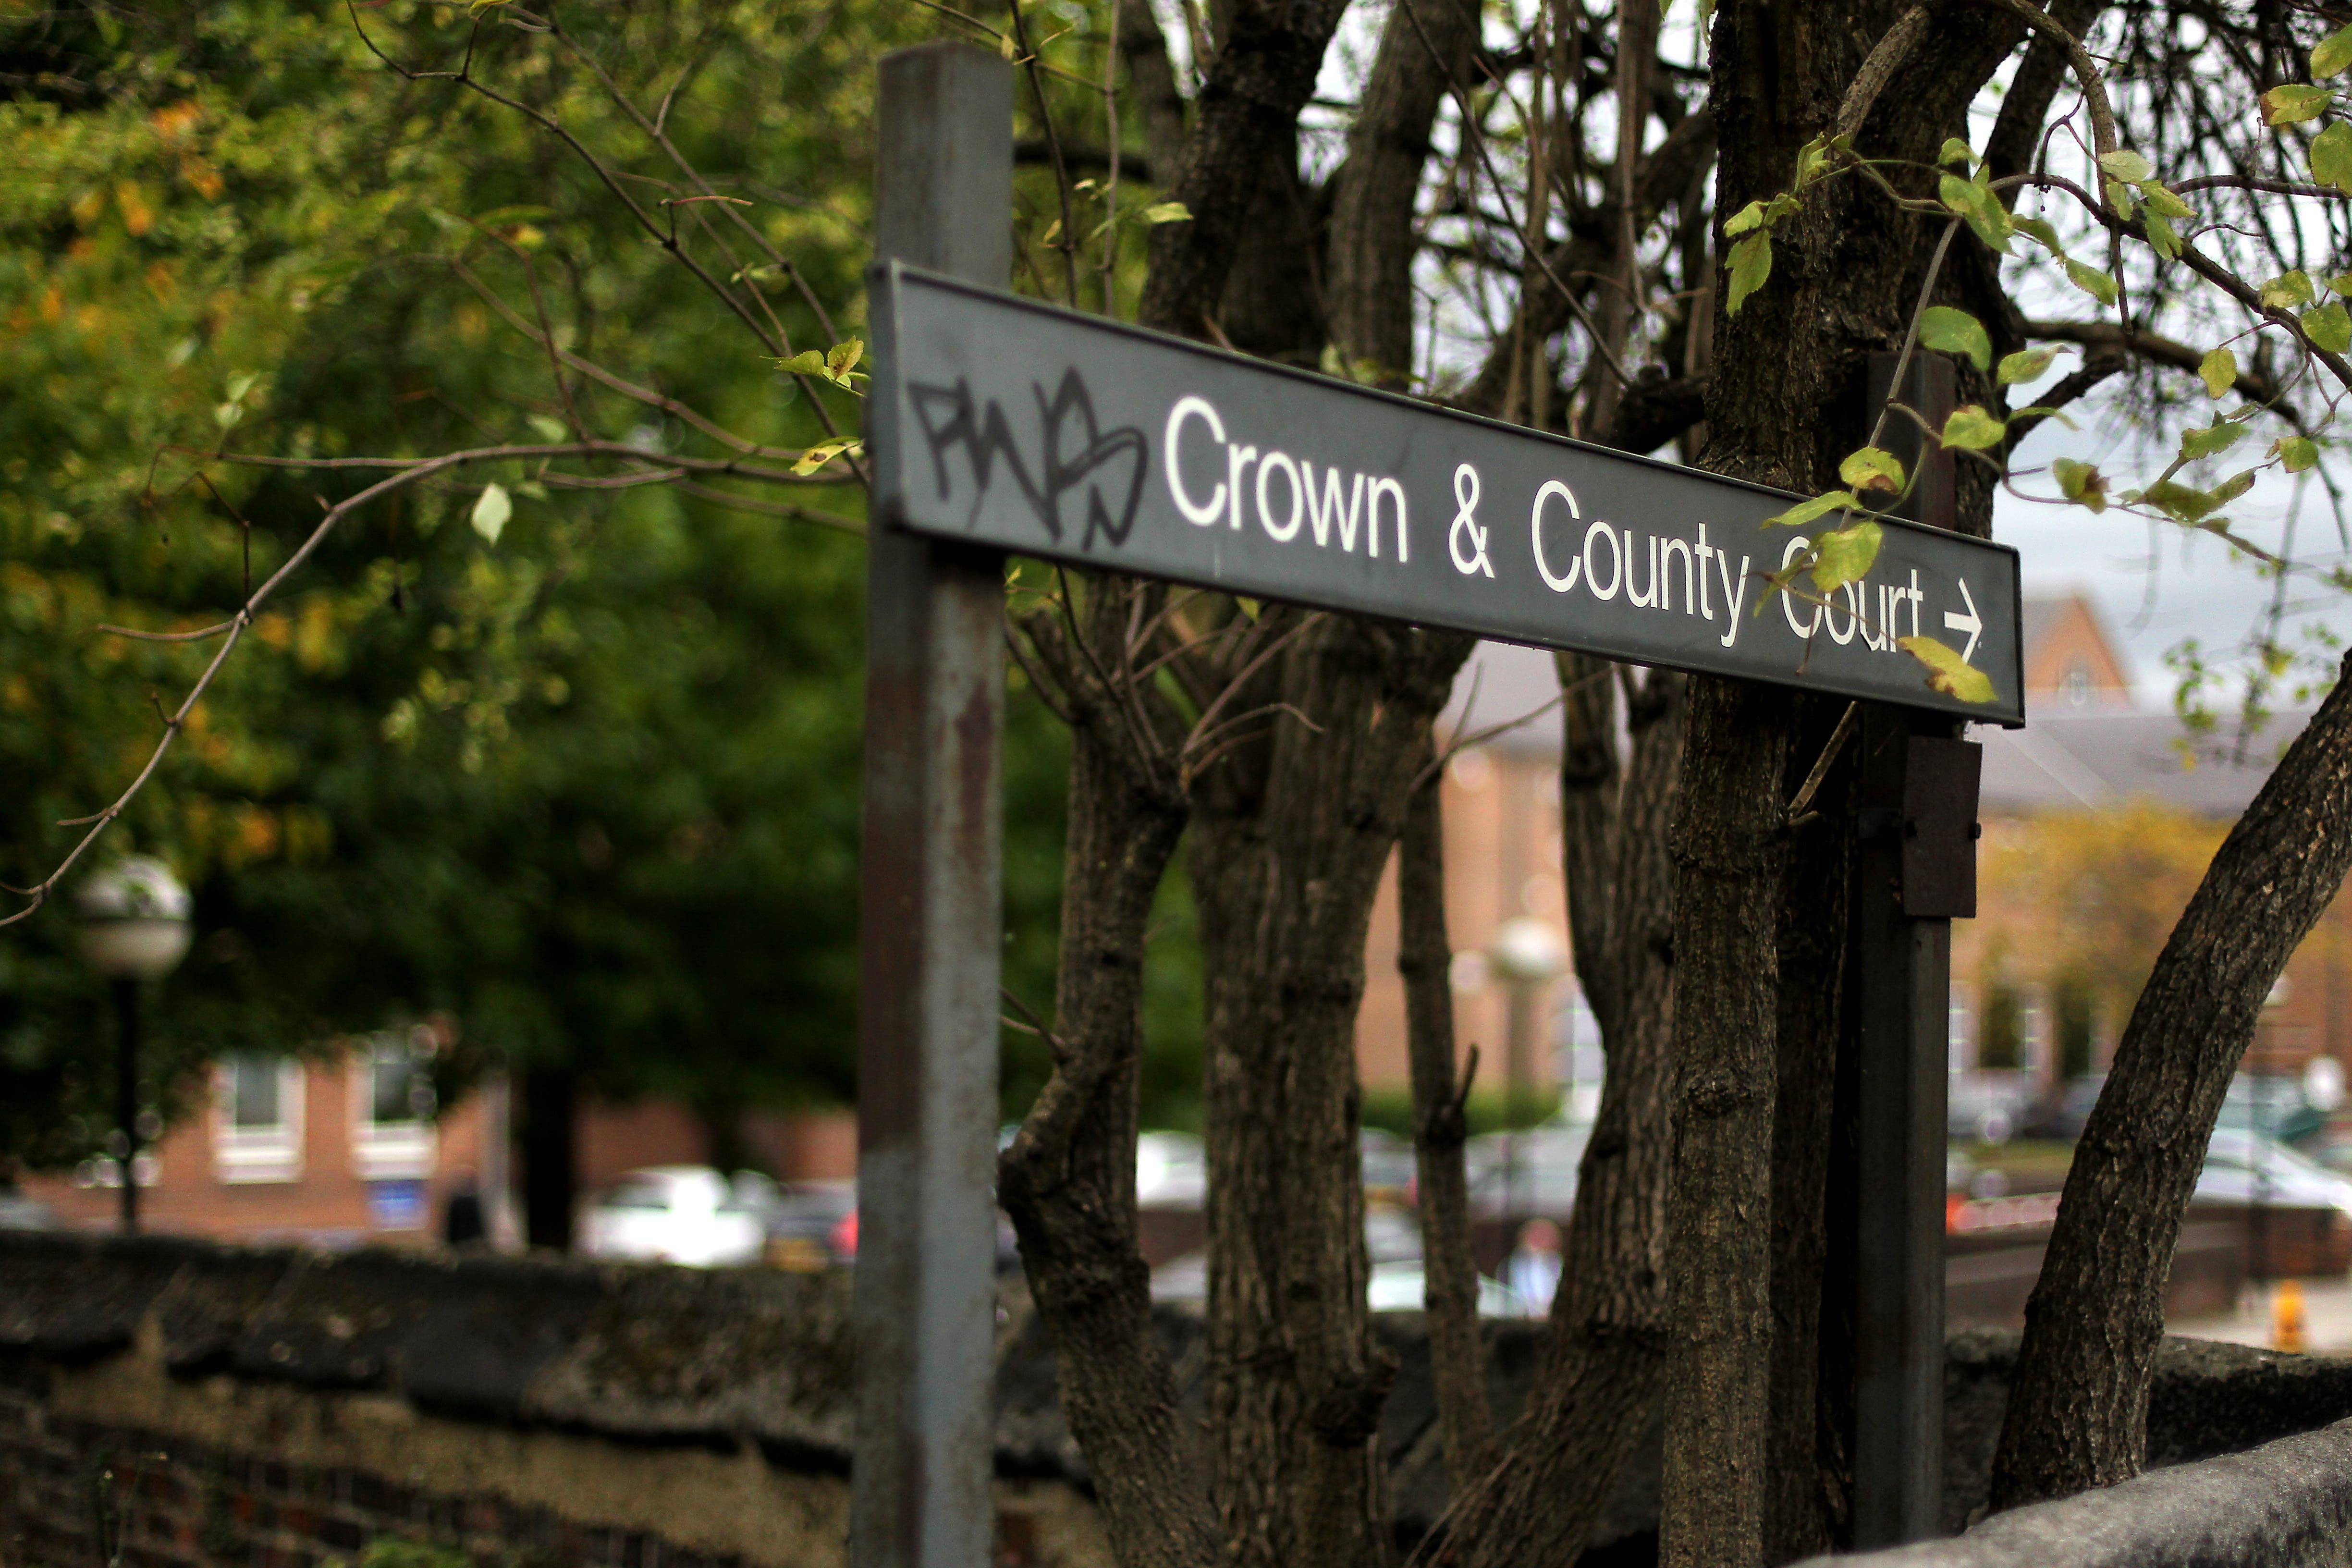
[1160,395,1411,562]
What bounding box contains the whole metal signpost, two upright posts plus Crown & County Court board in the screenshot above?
[851,45,2025,1568]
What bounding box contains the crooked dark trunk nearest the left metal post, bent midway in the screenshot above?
[997,578,1216,1568]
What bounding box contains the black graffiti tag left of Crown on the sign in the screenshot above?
[908,369,1150,550]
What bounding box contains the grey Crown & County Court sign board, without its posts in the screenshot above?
[868,263,2025,724]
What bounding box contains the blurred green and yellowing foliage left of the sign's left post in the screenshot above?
[0,0,1197,1164]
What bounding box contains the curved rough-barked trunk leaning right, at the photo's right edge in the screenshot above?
[1992,656,2352,1509]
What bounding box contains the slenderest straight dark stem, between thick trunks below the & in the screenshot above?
[1397,747,1494,1497]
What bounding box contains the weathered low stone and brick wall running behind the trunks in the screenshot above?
[13,1232,2352,1568]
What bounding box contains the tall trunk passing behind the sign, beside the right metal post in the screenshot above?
[1661,0,2018,1568]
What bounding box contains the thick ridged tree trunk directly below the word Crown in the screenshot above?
[1190,618,1470,1568]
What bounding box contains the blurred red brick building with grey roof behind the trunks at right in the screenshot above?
[1357,595,2352,1109]
